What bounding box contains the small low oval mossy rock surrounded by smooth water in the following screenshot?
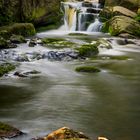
[75,66,100,73]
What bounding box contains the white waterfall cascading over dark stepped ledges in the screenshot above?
[62,0,102,32]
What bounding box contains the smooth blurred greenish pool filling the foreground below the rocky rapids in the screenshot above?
[0,35,140,140]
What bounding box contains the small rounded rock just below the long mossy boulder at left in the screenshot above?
[10,35,26,44]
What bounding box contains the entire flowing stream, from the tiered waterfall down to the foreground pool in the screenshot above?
[0,2,140,140]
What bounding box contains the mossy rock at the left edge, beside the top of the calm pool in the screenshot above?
[0,63,16,77]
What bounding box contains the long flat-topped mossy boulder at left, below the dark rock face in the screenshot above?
[0,23,36,37]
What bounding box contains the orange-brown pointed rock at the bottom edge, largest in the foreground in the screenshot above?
[33,127,89,140]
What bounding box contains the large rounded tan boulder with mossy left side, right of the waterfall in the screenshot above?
[102,16,140,36]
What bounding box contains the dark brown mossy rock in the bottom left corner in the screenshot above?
[0,122,23,138]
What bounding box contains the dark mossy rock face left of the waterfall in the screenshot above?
[0,0,60,26]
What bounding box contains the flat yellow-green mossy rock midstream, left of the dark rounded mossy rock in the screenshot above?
[42,38,76,49]
